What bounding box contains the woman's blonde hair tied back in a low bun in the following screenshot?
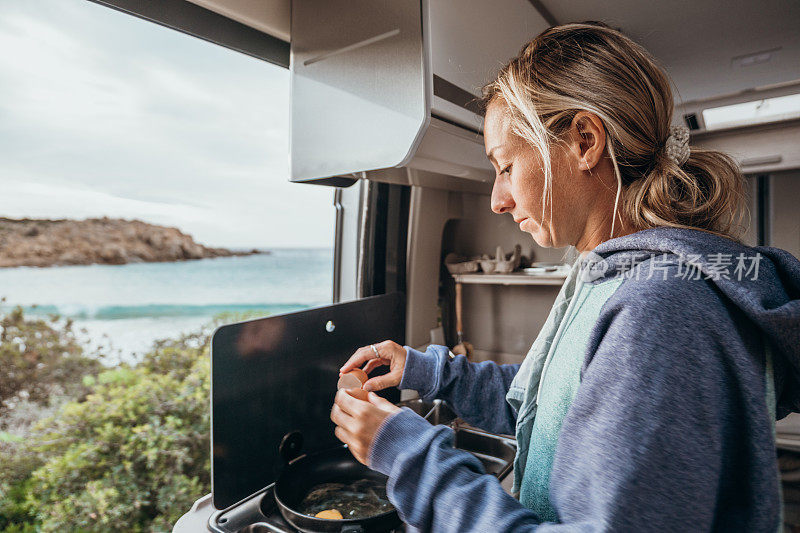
[482,22,743,238]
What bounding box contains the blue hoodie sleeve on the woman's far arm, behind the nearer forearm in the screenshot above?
[400,344,519,435]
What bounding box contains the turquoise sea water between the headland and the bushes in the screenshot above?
[0,249,333,360]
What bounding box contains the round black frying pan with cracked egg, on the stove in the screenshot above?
[275,435,401,533]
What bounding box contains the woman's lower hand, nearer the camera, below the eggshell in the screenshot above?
[331,389,400,466]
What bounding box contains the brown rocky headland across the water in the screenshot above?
[0,218,262,268]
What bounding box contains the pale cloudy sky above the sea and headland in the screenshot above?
[0,0,334,248]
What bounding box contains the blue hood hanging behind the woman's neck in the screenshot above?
[582,228,800,418]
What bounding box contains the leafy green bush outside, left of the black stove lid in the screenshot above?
[0,311,210,532]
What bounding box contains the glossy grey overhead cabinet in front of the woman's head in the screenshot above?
[290,0,547,192]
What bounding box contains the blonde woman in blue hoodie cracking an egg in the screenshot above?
[331,23,800,532]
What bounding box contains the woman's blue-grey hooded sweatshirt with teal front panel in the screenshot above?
[369,228,800,532]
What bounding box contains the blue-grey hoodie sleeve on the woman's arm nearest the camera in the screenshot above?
[369,274,778,532]
